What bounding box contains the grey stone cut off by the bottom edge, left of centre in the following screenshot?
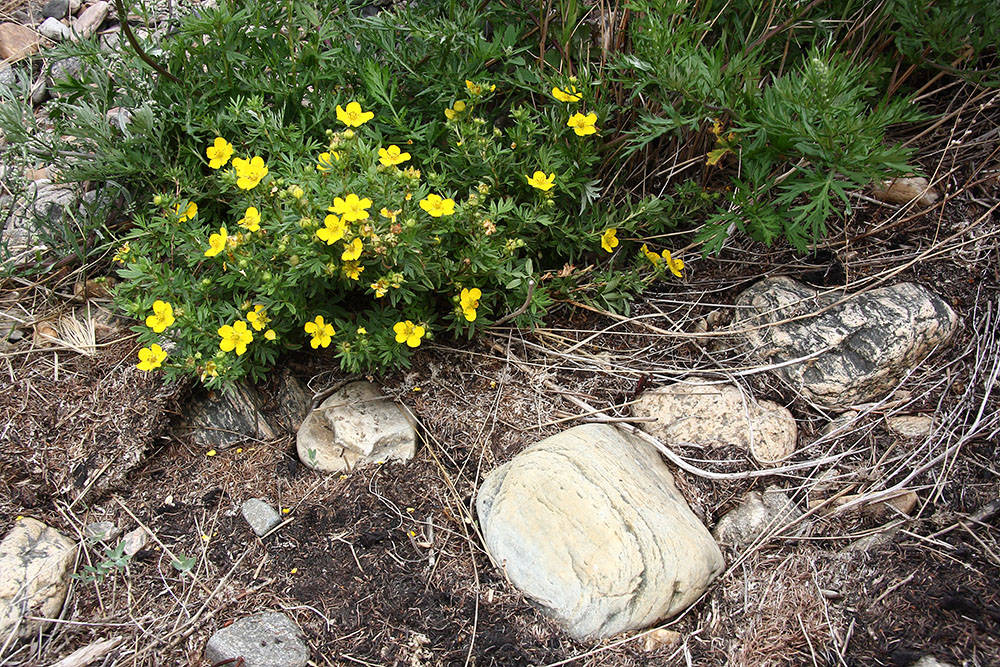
[205,611,309,667]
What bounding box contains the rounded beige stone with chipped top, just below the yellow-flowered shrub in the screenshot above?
[296,381,417,472]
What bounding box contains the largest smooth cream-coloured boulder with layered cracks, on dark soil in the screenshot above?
[476,424,724,639]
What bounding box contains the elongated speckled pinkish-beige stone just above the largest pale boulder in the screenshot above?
[632,378,798,463]
